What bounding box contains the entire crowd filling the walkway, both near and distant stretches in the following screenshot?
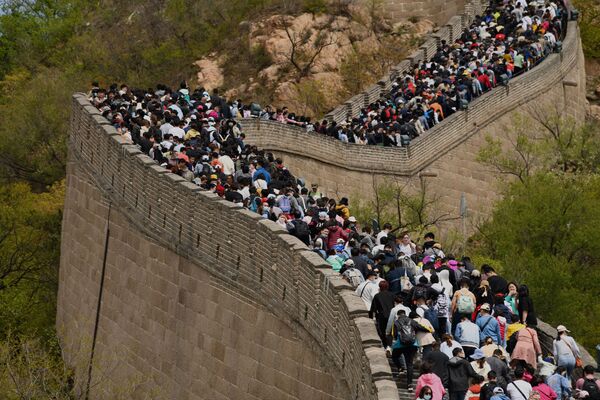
[89,0,600,400]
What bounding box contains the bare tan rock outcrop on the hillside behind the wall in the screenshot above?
[196,7,434,116]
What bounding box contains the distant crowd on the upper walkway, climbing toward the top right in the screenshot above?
[251,0,568,146]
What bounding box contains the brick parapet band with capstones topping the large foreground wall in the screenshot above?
[70,94,398,399]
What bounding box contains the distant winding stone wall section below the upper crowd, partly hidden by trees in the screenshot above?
[242,22,586,233]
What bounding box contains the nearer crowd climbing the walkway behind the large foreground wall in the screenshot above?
[89,77,600,400]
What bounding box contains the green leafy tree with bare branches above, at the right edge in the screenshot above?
[470,110,600,348]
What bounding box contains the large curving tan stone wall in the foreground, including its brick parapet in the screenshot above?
[57,95,398,400]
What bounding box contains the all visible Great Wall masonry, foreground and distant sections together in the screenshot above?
[57,2,591,400]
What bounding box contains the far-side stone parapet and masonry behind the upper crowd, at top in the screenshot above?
[325,0,489,122]
